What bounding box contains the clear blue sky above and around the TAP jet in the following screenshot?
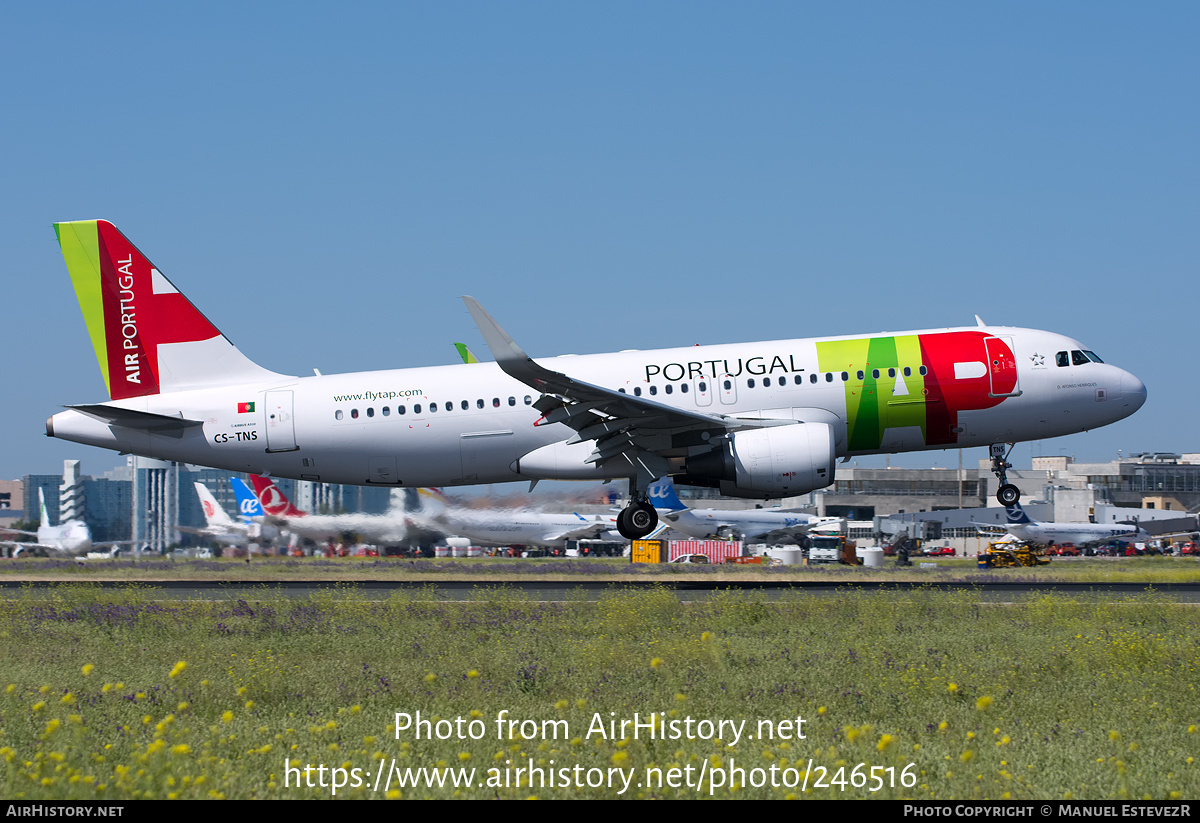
[0,2,1200,477]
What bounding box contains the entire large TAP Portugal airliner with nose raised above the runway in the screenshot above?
[46,221,1146,539]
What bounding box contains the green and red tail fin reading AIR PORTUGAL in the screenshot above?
[54,220,285,400]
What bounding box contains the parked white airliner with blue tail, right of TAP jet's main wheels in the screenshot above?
[649,479,845,543]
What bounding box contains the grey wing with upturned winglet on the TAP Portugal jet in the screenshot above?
[463,296,794,487]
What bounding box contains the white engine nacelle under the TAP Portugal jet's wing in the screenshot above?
[685,423,838,498]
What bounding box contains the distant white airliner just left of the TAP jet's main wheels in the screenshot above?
[410,488,622,548]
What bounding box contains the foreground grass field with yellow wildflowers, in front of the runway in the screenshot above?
[0,584,1200,799]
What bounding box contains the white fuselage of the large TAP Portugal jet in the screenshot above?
[47,328,1146,494]
